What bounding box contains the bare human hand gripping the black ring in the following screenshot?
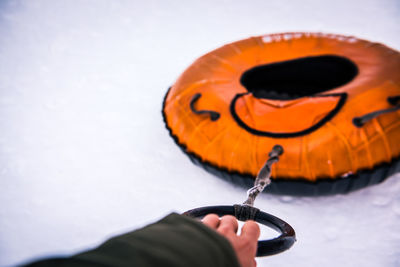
[202,214,260,267]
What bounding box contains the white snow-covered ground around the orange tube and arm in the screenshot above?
[0,0,400,267]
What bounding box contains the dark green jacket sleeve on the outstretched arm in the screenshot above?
[26,213,239,267]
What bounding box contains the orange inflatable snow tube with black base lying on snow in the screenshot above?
[163,33,400,195]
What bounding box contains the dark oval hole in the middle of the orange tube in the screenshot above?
[240,55,358,100]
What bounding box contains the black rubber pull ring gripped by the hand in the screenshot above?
[183,206,296,257]
